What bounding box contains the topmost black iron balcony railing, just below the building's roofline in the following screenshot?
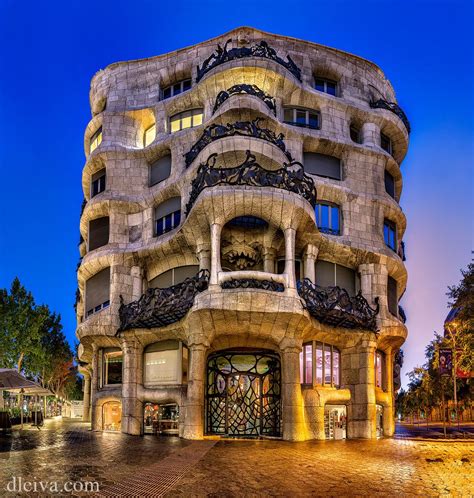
[196,39,301,83]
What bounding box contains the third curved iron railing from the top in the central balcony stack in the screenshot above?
[184,118,293,168]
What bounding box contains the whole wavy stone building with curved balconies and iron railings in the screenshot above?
[76,27,409,440]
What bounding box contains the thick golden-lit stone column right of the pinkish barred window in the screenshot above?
[344,340,376,439]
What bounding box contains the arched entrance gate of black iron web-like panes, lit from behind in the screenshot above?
[206,350,281,437]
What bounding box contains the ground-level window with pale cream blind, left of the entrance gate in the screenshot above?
[143,340,188,387]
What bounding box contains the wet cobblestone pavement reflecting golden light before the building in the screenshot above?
[0,421,474,498]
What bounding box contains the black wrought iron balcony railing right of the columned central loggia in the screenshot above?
[298,278,379,331]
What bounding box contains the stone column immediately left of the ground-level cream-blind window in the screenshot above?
[122,339,143,435]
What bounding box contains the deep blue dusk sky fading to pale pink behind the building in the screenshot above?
[0,0,474,386]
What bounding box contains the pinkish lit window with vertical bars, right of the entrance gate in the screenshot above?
[300,341,341,387]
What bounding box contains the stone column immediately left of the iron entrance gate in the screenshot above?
[183,343,208,439]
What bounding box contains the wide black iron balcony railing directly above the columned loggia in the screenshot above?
[186,150,316,215]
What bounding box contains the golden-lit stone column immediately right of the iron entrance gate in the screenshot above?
[280,339,306,441]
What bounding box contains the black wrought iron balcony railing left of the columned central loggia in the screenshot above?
[119,270,209,331]
